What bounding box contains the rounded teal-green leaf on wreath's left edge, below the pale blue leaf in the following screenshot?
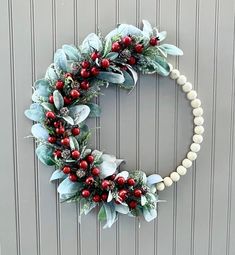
[36,144,55,166]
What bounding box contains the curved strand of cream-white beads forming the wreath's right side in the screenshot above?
[157,64,204,191]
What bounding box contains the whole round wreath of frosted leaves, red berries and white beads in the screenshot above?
[25,20,204,228]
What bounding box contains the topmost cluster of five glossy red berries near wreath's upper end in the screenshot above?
[112,36,159,65]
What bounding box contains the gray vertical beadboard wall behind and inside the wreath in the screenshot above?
[0,0,235,255]
